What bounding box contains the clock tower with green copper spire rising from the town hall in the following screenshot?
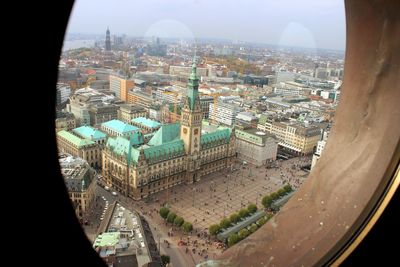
[181,55,203,183]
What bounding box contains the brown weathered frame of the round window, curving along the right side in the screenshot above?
[209,0,400,266]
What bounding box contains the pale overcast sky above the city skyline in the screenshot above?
[68,0,346,50]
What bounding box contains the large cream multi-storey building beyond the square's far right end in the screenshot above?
[257,116,321,155]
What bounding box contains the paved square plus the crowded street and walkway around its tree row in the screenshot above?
[85,157,311,266]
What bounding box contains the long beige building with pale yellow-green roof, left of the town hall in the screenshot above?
[57,130,101,168]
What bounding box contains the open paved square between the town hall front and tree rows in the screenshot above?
[148,157,311,236]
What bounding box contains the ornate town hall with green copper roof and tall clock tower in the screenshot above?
[103,59,236,199]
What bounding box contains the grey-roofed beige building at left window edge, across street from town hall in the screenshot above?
[59,154,96,222]
